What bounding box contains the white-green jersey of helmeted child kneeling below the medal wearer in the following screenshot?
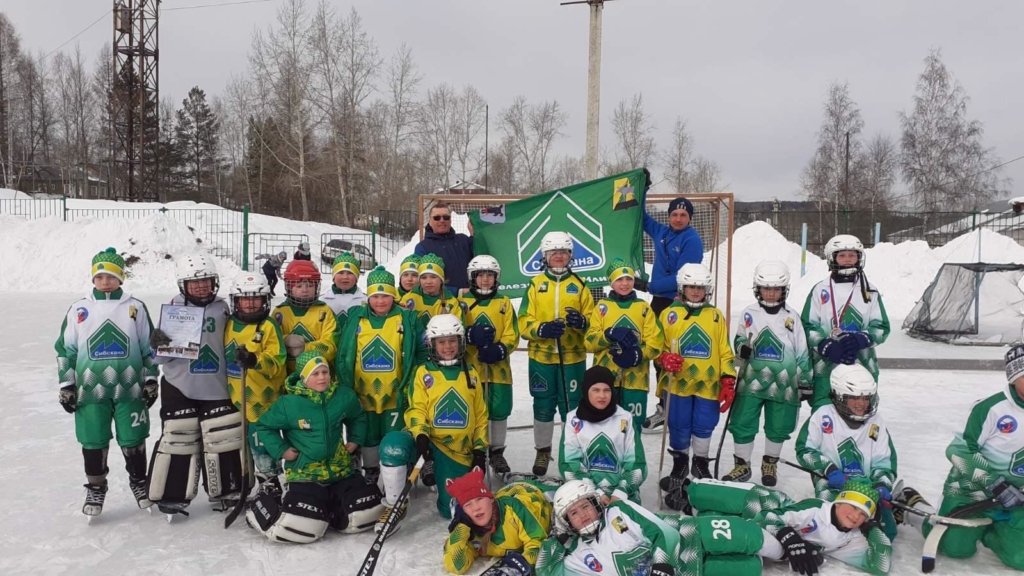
[796,404,896,494]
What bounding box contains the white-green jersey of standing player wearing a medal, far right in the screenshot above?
[801,276,889,381]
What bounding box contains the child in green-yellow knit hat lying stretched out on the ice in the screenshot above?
[689,479,893,576]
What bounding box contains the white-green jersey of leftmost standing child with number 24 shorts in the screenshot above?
[53,289,157,404]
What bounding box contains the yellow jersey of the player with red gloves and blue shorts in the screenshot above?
[657,300,736,401]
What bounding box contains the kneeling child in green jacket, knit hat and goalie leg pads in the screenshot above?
[246,352,383,544]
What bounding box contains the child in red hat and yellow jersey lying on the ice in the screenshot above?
[444,469,551,576]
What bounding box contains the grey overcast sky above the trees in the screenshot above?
[0,0,1024,200]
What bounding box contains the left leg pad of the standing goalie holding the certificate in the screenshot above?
[148,417,203,504]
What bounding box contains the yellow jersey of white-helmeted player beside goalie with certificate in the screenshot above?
[224,318,287,422]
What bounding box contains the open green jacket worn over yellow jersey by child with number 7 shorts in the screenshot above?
[334,300,427,412]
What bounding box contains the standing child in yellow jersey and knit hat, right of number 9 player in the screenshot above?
[587,258,665,431]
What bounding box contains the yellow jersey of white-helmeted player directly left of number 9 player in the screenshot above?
[459,293,519,384]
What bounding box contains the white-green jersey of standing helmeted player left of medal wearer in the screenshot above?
[733,304,811,406]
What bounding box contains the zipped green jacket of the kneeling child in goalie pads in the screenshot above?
[254,373,367,483]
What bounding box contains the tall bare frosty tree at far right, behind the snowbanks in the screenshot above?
[899,49,1010,211]
